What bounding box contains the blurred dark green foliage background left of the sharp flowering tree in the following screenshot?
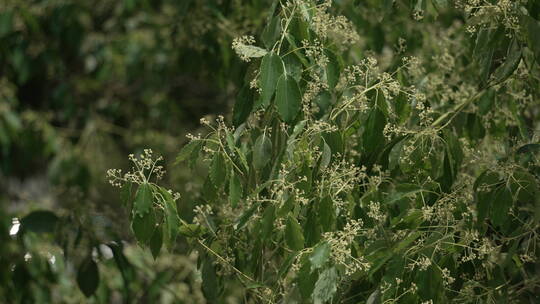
[0,0,268,303]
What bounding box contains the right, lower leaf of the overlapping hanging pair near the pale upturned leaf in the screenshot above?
[276,75,302,123]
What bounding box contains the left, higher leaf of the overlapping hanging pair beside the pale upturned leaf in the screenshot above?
[259,53,283,107]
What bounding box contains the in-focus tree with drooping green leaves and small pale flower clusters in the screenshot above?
[110,1,540,303]
